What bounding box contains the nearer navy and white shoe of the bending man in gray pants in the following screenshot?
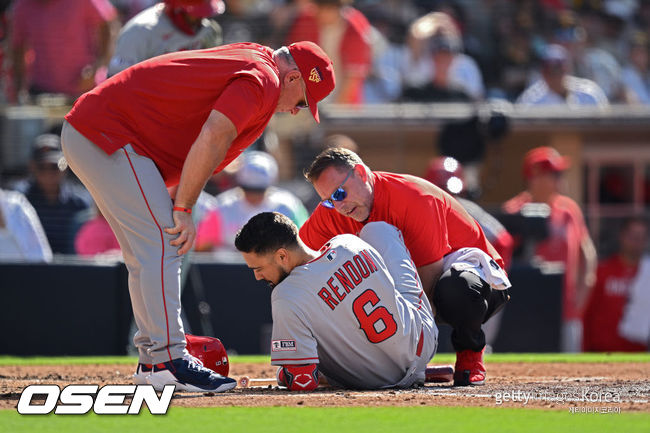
[146,358,237,392]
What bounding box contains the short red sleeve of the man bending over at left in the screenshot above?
[212,78,266,134]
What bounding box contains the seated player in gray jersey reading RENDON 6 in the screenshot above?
[235,212,438,391]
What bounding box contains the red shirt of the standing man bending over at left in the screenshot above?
[65,43,280,186]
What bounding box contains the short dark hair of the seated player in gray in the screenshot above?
[235,212,298,254]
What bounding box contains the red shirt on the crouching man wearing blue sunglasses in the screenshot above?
[300,172,504,268]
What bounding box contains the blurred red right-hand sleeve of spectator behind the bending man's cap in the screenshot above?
[341,8,372,78]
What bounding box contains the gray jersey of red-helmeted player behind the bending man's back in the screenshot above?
[108,3,222,76]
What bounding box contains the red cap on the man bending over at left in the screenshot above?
[288,41,336,122]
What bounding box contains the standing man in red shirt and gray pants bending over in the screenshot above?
[62,42,334,392]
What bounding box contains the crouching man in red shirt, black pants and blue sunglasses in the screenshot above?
[300,148,510,385]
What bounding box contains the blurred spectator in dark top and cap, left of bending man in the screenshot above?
[16,134,91,254]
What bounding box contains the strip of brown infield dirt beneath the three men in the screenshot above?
[0,363,650,413]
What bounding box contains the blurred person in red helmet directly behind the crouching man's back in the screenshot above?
[424,156,514,269]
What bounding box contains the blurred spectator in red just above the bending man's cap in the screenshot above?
[286,0,372,104]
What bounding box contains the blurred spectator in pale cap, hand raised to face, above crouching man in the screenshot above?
[402,12,485,102]
